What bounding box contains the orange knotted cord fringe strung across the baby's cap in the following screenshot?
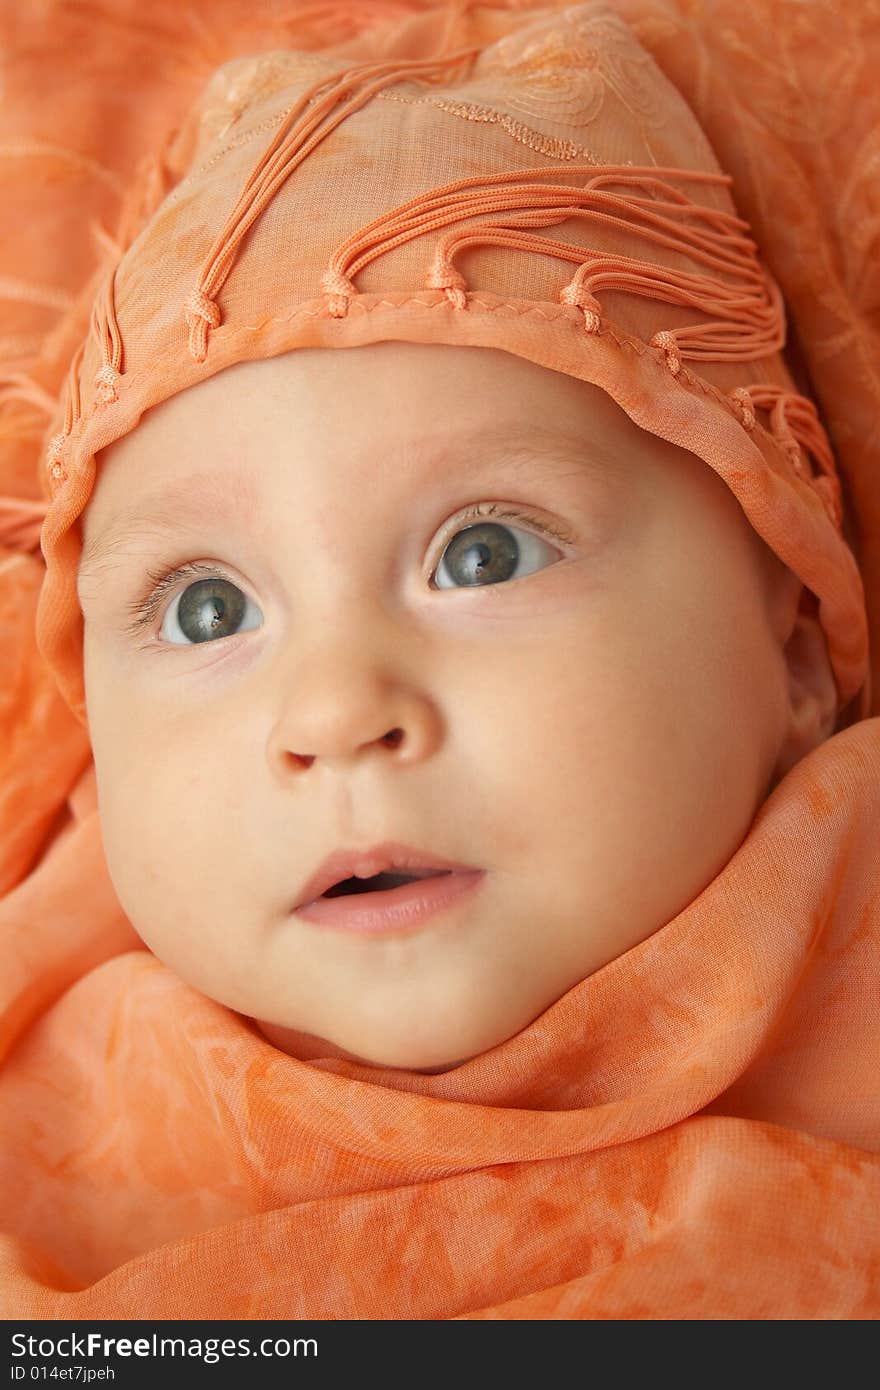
[46,39,842,528]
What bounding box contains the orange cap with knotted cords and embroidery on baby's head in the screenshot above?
[27,0,870,721]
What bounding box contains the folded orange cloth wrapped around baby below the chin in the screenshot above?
[0,720,880,1318]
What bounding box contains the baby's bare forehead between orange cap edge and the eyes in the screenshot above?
[81,341,748,570]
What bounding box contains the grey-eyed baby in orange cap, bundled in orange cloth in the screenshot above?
[0,0,880,1319]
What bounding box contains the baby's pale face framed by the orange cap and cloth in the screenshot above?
[79,342,799,1072]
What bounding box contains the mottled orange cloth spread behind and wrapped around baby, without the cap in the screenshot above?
[0,0,880,1319]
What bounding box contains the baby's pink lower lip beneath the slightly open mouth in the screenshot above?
[293,869,485,935]
